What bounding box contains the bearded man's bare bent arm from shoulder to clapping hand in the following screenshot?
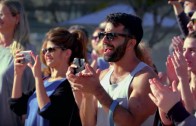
[67,65,157,126]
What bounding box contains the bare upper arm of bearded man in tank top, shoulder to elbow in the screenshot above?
[125,68,157,125]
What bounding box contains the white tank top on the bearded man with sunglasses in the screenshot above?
[96,62,148,126]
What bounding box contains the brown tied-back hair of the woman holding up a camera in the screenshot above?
[40,27,87,76]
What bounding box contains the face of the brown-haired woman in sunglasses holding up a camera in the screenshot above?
[42,41,64,68]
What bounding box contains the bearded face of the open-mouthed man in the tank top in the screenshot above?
[102,23,127,62]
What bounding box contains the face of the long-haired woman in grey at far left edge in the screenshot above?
[0,4,18,32]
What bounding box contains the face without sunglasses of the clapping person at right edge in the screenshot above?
[183,38,196,73]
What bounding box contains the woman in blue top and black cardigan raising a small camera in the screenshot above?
[10,27,86,126]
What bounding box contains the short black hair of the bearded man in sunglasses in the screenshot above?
[106,12,143,48]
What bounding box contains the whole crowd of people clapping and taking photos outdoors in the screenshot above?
[0,0,196,126]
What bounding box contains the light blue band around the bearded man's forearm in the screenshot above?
[109,100,118,126]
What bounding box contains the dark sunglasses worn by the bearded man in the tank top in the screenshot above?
[98,32,133,41]
